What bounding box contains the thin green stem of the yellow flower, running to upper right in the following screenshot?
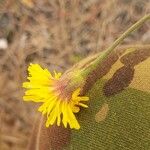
[81,14,150,76]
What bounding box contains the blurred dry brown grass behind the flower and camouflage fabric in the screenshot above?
[0,0,150,150]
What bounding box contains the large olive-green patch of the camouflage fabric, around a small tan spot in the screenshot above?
[66,80,150,150]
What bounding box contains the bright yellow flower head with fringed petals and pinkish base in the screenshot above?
[23,64,89,129]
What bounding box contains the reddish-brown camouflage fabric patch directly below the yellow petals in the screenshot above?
[39,117,71,150]
